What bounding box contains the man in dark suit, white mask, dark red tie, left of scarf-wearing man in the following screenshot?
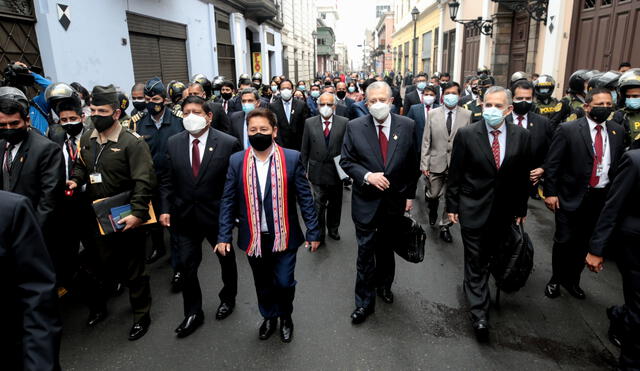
[160,97,241,337]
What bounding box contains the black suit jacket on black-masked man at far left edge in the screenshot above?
[0,129,65,231]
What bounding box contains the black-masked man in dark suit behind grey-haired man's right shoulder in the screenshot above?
[505,80,553,200]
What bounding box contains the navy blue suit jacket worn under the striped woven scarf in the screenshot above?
[218,148,320,251]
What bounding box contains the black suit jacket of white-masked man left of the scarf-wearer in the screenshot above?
[159,128,241,233]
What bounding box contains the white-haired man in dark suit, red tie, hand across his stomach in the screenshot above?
[340,81,420,324]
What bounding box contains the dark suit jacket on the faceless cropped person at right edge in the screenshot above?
[592,149,640,256]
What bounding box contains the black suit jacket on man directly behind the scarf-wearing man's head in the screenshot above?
[268,98,308,151]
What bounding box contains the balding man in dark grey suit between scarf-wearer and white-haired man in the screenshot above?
[301,93,348,244]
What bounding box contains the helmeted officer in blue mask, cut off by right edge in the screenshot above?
[613,68,640,148]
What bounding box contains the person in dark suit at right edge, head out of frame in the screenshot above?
[586,149,640,370]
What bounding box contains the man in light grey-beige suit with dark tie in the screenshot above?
[420,82,471,242]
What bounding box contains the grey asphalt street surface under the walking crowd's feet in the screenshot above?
[61,182,622,370]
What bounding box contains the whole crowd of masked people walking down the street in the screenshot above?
[0,58,640,370]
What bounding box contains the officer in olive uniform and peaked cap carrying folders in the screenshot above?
[67,85,156,340]
